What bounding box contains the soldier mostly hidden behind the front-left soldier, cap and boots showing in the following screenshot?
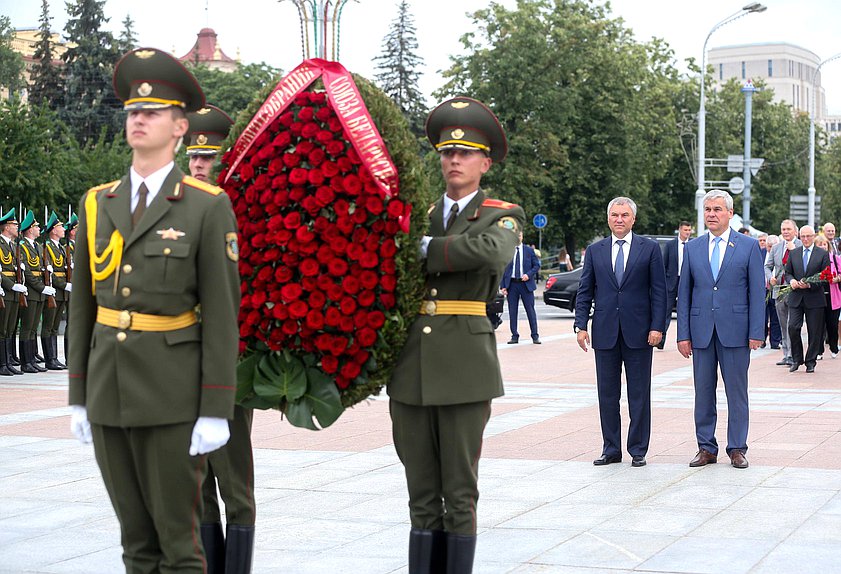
[184,105,256,574]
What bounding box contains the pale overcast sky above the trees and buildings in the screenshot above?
[0,0,841,114]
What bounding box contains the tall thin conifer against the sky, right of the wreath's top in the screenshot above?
[374,0,426,137]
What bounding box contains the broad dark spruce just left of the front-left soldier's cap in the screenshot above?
[60,0,122,145]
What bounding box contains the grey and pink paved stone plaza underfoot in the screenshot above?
[0,303,841,574]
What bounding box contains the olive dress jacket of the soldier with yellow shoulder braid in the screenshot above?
[68,167,240,427]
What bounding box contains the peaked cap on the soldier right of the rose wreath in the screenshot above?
[426,96,508,162]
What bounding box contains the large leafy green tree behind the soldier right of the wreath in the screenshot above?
[436,0,683,253]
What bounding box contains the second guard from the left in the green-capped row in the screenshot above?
[19,210,56,373]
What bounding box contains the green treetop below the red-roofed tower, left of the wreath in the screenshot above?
[188,62,281,120]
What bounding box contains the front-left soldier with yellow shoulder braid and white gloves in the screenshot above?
[68,48,239,574]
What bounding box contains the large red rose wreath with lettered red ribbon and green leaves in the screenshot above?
[218,60,431,430]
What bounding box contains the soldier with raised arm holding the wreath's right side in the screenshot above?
[388,97,525,574]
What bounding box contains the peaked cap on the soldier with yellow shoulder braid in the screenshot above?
[114,48,204,112]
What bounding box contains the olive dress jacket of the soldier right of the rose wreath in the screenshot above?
[388,190,525,406]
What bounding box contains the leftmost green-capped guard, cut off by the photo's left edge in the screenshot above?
[0,207,26,376]
